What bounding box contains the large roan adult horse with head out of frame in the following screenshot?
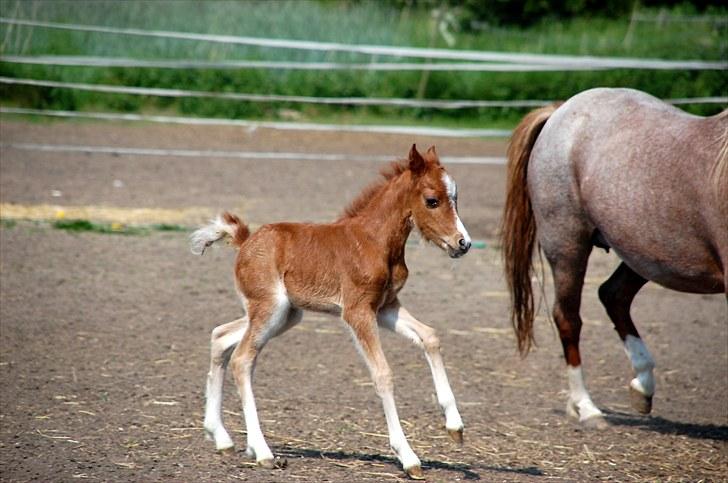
[501,89,728,427]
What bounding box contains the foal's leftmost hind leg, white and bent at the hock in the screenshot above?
[203,317,248,451]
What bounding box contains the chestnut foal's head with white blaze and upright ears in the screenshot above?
[408,144,470,258]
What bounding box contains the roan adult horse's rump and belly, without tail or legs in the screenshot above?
[528,89,728,292]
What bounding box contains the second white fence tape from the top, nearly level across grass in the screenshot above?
[0,55,616,72]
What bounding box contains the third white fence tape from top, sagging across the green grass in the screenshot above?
[0,77,728,109]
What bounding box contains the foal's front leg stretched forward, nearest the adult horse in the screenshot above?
[377,301,463,443]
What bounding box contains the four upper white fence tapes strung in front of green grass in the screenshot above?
[0,17,728,137]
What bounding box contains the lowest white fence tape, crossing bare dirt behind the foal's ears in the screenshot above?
[0,143,506,165]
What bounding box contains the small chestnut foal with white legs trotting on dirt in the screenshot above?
[191,145,470,479]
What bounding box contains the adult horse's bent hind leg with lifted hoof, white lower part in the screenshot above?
[599,263,655,414]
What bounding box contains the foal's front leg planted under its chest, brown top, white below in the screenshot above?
[343,307,424,480]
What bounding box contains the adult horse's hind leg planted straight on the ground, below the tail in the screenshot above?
[544,248,606,428]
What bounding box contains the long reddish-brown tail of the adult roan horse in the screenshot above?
[500,103,560,355]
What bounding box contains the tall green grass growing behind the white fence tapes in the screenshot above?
[0,0,728,126]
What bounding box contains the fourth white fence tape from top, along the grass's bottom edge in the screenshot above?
[0,107,511,138]
